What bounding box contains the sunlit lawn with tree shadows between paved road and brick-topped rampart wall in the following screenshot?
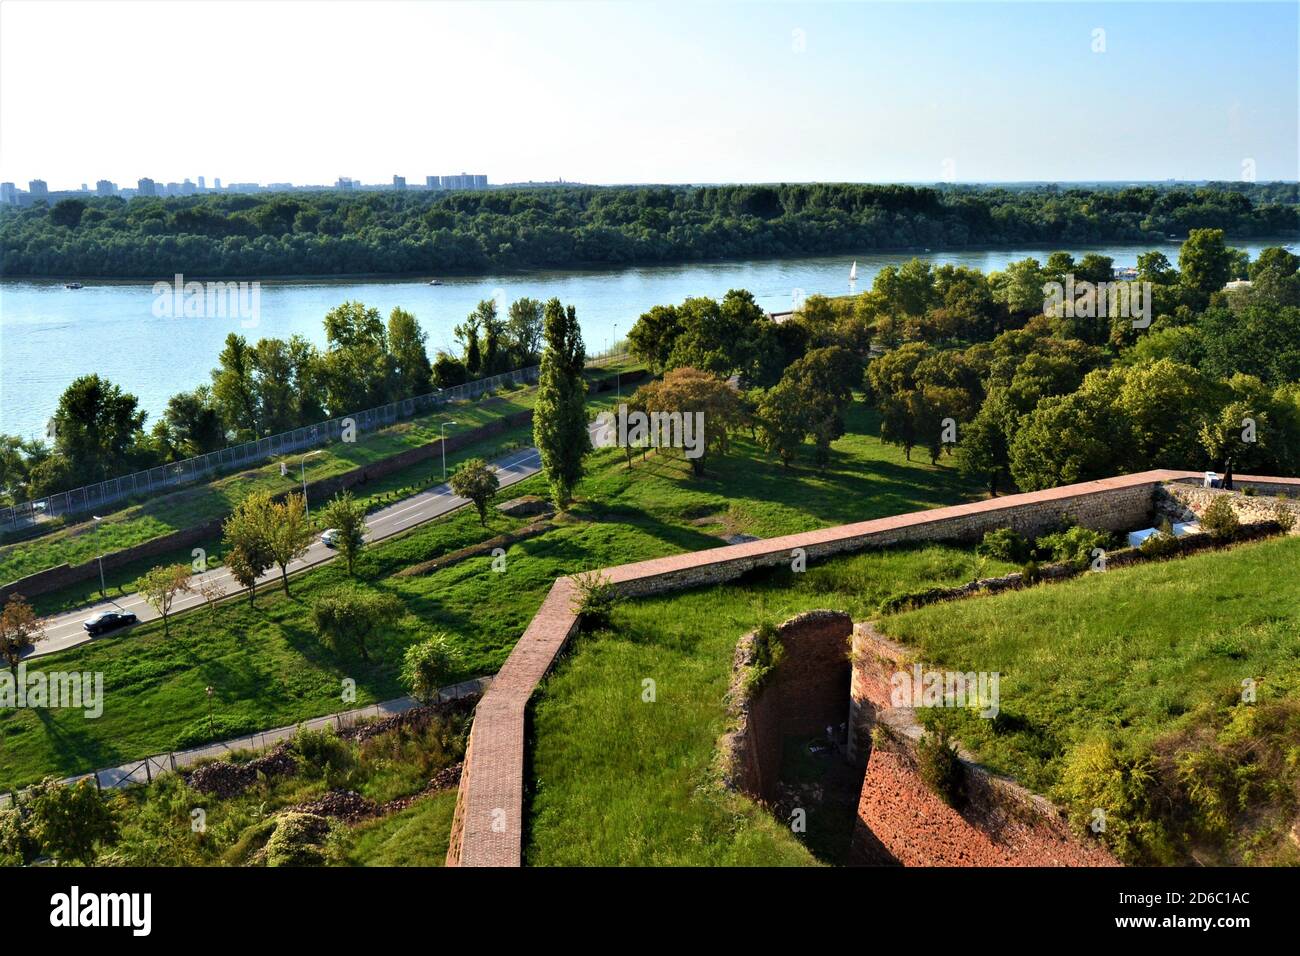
[0,412,974,788]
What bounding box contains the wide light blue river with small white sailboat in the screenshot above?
[0,239,1287,437]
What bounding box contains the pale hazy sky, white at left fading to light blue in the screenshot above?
[0,0,1300,189]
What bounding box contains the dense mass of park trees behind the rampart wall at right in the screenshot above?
[618,229,1300,493]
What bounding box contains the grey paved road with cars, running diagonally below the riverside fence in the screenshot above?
[25,437,564,658]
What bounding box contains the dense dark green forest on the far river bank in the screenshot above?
[0,182,1300,278]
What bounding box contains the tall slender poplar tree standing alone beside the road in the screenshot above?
[533,299,592,510]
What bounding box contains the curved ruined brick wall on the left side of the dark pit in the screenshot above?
[720,610,853,803]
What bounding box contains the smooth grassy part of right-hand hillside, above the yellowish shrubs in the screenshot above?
[880,537,1300,793]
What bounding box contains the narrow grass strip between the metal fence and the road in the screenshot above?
[0,360,641,587]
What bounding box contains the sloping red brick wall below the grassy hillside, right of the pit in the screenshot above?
[849,624,1117,866]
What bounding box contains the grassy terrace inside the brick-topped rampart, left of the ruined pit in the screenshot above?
[525,545,1001,866]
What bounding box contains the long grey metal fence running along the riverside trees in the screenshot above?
[0,351,625,529]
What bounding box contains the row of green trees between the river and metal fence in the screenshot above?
[0,298,542,503]
